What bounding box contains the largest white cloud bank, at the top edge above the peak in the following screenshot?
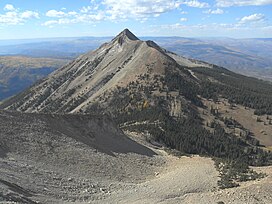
[42,0,181,27]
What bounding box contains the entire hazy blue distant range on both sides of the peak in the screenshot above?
[0,37,272,81]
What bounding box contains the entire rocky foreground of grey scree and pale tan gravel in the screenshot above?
[0,112,272,204]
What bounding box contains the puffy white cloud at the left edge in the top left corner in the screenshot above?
[0,5,39,25]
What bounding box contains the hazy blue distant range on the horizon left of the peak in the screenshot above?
[0,37,110,59]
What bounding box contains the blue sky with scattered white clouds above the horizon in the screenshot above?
[0,0,272,39]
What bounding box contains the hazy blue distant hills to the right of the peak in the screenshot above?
[155,37,272,81]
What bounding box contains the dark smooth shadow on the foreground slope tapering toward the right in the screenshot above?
[45,115,156,156]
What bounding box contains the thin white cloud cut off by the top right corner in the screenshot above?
[216,0,272,7]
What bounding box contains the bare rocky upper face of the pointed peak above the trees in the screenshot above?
[0,29,203,113]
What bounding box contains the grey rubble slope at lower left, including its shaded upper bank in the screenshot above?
[0,111,159,203]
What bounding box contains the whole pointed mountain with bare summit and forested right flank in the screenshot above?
[0,30,272,165]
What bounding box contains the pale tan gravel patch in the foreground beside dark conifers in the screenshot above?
[97,156,218,204]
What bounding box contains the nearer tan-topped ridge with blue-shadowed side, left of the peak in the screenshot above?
[0,56,68,100]
